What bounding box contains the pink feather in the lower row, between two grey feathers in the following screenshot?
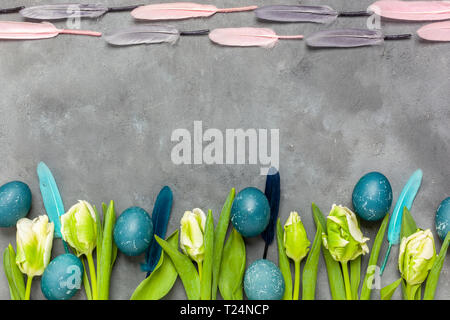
[209,28,303,48]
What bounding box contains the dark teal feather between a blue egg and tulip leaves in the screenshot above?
[141,186,173,277]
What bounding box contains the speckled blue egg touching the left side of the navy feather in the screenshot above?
[231,187,270,237]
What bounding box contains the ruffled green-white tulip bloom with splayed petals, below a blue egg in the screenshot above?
[322,205,369,263]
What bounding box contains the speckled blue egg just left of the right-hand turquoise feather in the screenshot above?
[352,172,392,221]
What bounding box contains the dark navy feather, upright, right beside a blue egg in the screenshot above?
[261,167,280,259]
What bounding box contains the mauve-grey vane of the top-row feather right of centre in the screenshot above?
[255,5,338,23]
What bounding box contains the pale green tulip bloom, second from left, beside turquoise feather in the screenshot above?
[61,200,97,256]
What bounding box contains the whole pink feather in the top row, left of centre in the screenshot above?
[131,2,257,20]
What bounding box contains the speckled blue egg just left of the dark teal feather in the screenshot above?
[114,207,153,256]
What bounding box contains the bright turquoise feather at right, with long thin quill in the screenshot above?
[380,169,423,275]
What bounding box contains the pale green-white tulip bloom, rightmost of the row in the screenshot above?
[398,229,436,286]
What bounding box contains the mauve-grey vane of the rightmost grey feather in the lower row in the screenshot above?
[306,29,384,48]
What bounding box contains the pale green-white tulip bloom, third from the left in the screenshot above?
[180,208,206,263]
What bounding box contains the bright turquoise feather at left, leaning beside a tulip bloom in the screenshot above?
[37,162,65,238]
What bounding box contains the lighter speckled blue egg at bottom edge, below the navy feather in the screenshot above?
[244,259,285,300]
